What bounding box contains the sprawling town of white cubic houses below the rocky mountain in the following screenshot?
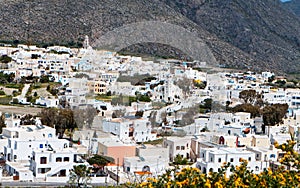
[0,38,300,183]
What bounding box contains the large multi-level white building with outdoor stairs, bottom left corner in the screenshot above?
[3,125,87,182]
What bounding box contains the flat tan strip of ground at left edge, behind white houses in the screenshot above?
[0,105,41,115]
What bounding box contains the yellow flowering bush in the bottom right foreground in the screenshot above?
[132,138,300,188]
